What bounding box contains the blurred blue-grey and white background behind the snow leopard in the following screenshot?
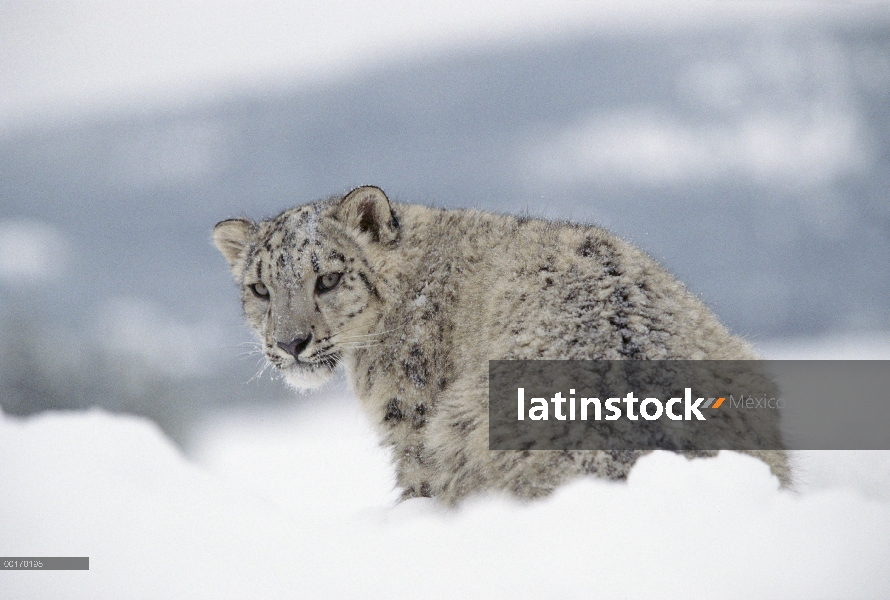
[0,0,890,448]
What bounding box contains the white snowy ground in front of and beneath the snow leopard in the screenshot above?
[0,337,890,598]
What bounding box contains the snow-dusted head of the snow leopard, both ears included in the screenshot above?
[213,186,399,389]
